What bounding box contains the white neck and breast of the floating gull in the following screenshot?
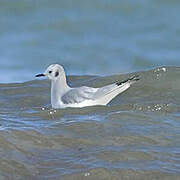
[51,75,70,108]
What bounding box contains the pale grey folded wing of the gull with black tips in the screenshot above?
[61,76,139,104]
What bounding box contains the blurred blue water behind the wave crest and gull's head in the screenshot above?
[0,0,180,83]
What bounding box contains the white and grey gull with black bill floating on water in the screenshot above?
[36,64,139,109]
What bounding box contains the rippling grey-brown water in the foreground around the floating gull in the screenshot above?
[0,67,180,180]
